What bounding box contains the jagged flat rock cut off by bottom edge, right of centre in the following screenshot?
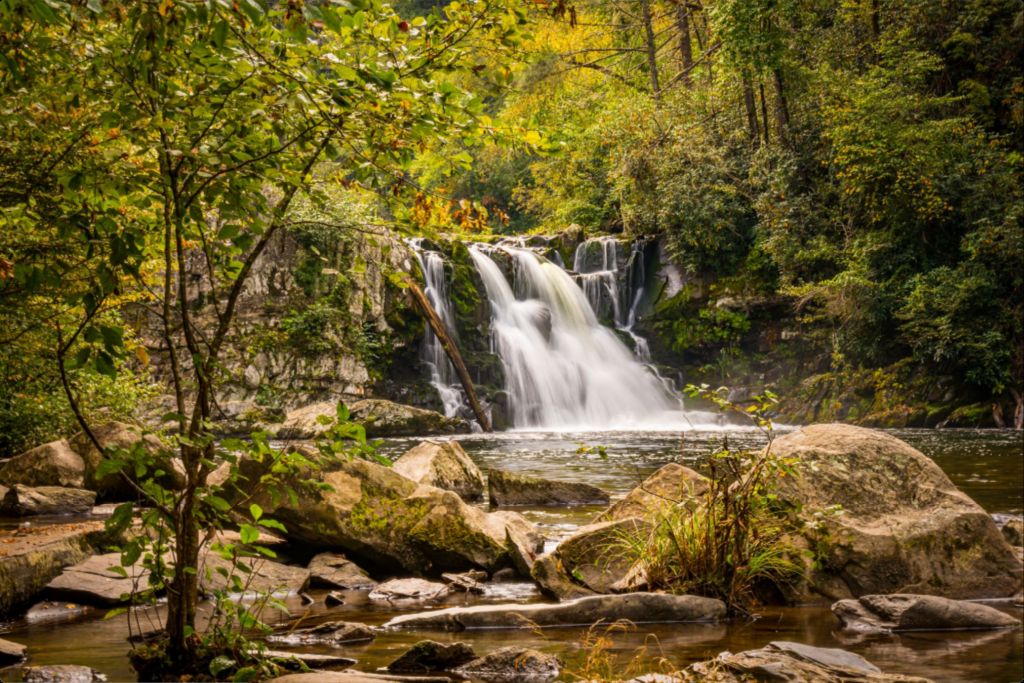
[678,641,930,683]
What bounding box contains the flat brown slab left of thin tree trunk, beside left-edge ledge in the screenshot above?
[45,553,150,606]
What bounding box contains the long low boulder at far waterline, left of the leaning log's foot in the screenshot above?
[276,398,469,439]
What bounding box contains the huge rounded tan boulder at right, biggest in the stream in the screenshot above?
[773,424,1022,600]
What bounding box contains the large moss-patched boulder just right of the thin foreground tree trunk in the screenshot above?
[243,460,540,575]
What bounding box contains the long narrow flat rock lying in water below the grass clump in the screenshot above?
[383,593,725,631]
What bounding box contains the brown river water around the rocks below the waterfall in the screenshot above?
[0,430,1024,683]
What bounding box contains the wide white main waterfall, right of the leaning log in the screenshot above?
[469,240,681,430]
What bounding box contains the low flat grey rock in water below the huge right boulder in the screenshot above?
[831,595,1021,633]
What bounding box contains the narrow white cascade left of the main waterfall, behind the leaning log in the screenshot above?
[410,240,466,418]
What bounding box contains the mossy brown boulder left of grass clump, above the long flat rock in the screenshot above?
[535,517,650,598]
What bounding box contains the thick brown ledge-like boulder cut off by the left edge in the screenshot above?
[0,521,106,617]
